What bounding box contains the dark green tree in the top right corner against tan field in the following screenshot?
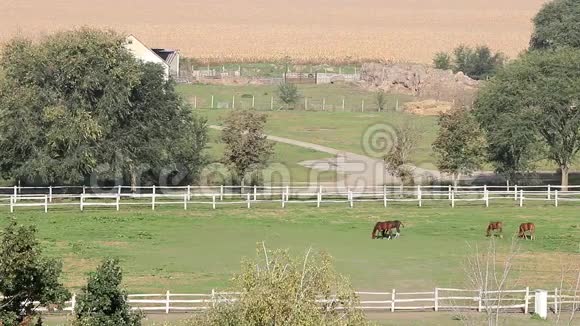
[530,0,580,50]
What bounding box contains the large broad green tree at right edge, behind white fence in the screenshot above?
[475,49,580,186]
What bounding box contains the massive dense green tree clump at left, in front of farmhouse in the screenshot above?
[0,29,205,184]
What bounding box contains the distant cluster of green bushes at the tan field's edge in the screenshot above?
[433,45,506,80]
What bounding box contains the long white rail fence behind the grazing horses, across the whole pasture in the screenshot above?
[0,185,580,212]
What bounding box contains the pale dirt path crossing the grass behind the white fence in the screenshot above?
[210,125,442,189]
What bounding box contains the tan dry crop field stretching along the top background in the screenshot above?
[0,0,545,63]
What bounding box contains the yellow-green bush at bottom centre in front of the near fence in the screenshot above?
[194,244,366,326]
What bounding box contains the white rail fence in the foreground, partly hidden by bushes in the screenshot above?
[14,288,580,314]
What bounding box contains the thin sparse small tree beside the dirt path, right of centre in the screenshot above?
[384,123,420,184]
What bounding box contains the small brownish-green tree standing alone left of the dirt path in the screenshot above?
[221,110,274,185]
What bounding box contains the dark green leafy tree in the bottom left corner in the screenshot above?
[0,221,70,326]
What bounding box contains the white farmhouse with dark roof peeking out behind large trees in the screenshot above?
[125,35,179,79]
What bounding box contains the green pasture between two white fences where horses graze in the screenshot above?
[1,201,580,293]
